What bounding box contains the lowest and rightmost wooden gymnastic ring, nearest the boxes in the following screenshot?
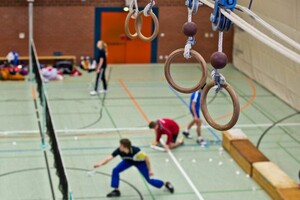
[200,81,240,131]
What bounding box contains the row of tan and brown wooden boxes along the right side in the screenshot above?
[222,129,300,200]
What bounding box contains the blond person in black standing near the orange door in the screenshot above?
[90,40,108,96]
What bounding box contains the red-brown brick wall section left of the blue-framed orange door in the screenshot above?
[0,7,94,58]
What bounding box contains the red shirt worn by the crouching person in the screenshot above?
[156,118,179,144]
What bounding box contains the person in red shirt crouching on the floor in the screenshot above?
[149,118,184,149]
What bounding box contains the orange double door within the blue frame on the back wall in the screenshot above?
[100,12,152,63]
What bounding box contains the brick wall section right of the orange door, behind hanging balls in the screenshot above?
[158,7,233,62]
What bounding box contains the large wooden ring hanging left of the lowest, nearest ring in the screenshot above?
[165,48,207,93]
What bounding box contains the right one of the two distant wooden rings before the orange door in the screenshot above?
[135,10,159,42]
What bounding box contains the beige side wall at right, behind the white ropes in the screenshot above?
[233,0,300,111]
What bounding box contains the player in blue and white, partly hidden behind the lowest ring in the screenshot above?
[182,83,206,144]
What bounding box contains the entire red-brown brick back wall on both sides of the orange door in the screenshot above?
[0,0,233,62]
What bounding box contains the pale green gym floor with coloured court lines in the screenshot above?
[0,64,300,200]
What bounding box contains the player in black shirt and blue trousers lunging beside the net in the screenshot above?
[94,139,174,197]
